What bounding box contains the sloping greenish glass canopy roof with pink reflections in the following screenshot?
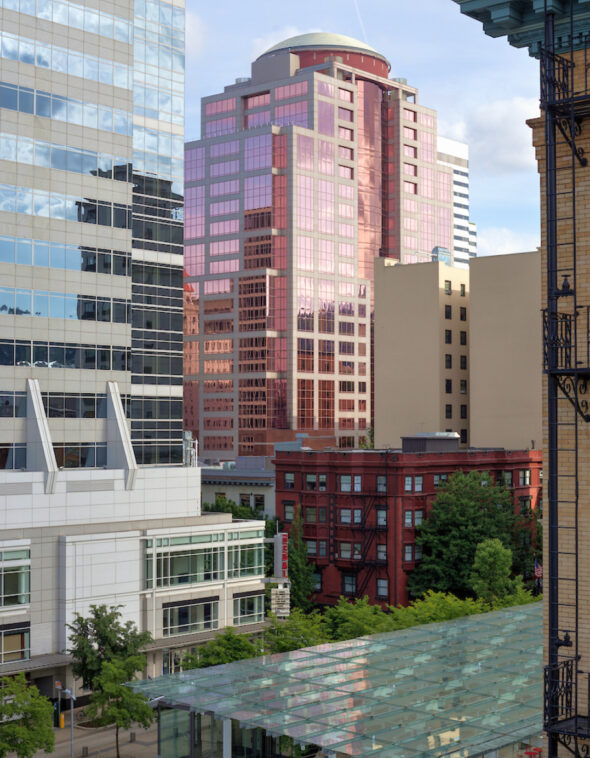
[133,603,542,758]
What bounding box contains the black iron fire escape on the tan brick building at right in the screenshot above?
[540,0,590,758]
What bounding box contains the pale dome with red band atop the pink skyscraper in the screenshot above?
[257,32,391,77]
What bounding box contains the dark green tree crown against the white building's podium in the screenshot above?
[68,605,152,690]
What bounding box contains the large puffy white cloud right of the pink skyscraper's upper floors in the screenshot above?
[439,97,539,179]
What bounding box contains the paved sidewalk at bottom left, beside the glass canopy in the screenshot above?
[36,709,158,758]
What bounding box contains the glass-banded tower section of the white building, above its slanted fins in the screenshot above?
[0,0,184,470]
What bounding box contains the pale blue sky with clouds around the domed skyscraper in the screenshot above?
[185,0,540,255]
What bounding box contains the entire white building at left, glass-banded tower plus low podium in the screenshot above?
[0,0,263,695]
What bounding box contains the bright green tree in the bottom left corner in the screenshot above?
[0,672,55,758]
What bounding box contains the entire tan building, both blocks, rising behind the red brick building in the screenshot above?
[375,252,542,450]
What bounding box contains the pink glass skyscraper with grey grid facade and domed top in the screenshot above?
[184,33,474,459]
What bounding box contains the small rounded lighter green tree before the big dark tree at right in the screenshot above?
[470,539,521,604]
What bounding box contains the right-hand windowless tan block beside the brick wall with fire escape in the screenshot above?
[469,251,543,450]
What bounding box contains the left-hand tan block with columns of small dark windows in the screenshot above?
[375,259,470,447]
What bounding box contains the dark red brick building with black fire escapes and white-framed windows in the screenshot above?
[275,434,542,605]
